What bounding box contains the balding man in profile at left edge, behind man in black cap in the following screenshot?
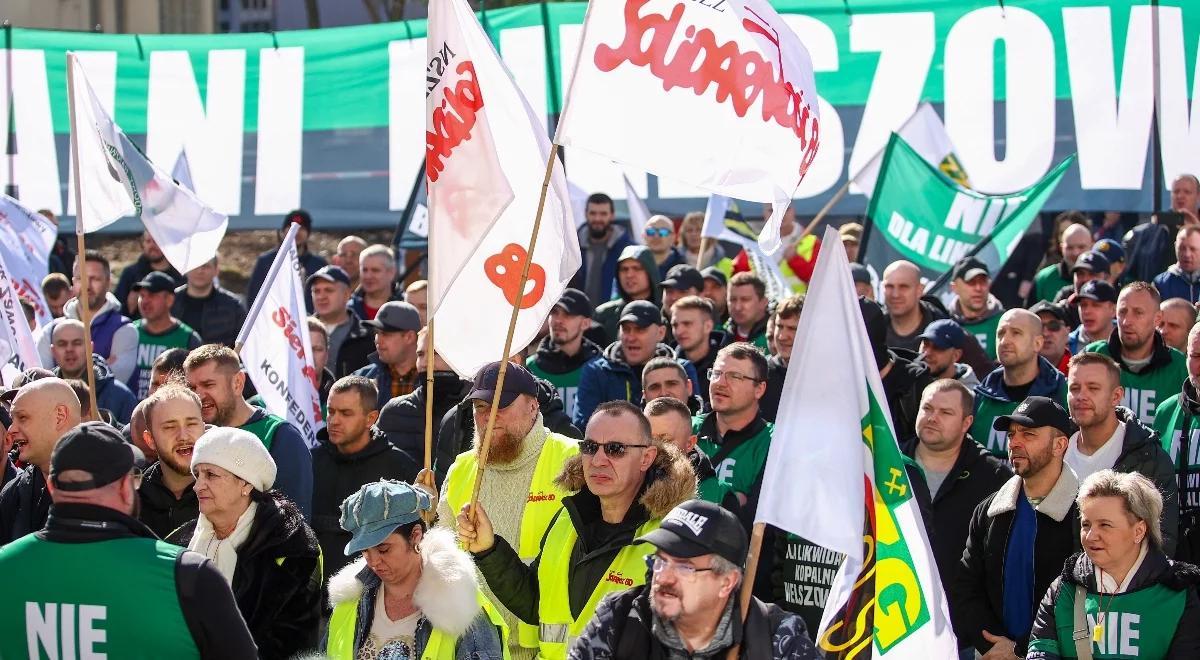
[0,378,79,546]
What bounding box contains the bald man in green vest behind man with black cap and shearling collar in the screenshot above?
[971,310,1067,458]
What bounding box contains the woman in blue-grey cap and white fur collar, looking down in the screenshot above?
[324,479,508,660]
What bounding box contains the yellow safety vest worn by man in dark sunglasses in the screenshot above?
[538,514,662,660]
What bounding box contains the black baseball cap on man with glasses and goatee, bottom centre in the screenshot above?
[634,499,749,566]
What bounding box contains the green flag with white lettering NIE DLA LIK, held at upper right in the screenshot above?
[863,133,1075,286]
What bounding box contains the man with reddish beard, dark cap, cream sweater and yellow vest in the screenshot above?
[438,362,580,660]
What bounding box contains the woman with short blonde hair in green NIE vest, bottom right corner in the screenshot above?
[1026,469,1200,660]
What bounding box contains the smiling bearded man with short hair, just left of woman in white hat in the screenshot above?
[138,383,204,539]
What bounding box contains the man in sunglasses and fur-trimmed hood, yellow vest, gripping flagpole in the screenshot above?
[457,401,696,660]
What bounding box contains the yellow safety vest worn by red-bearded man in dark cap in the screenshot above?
[445,432,580,648]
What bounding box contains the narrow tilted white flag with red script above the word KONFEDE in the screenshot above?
[238,224,324,448]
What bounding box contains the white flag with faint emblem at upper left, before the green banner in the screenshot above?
[67,53,229,272]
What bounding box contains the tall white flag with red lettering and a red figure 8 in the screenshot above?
[426,0,581,377]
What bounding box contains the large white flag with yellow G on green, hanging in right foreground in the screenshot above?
[755,228,958,658]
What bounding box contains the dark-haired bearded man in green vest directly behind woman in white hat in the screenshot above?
[184,343,312,518]
